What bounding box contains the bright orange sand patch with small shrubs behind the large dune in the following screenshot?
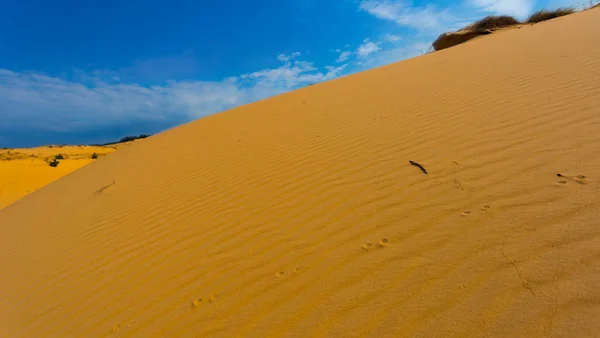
[0,142,131,209]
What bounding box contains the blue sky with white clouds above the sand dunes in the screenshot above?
[0,0,583,147]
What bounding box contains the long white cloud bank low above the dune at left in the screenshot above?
[0,53,346,132]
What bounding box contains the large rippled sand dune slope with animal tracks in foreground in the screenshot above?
[0,10,600,337]
